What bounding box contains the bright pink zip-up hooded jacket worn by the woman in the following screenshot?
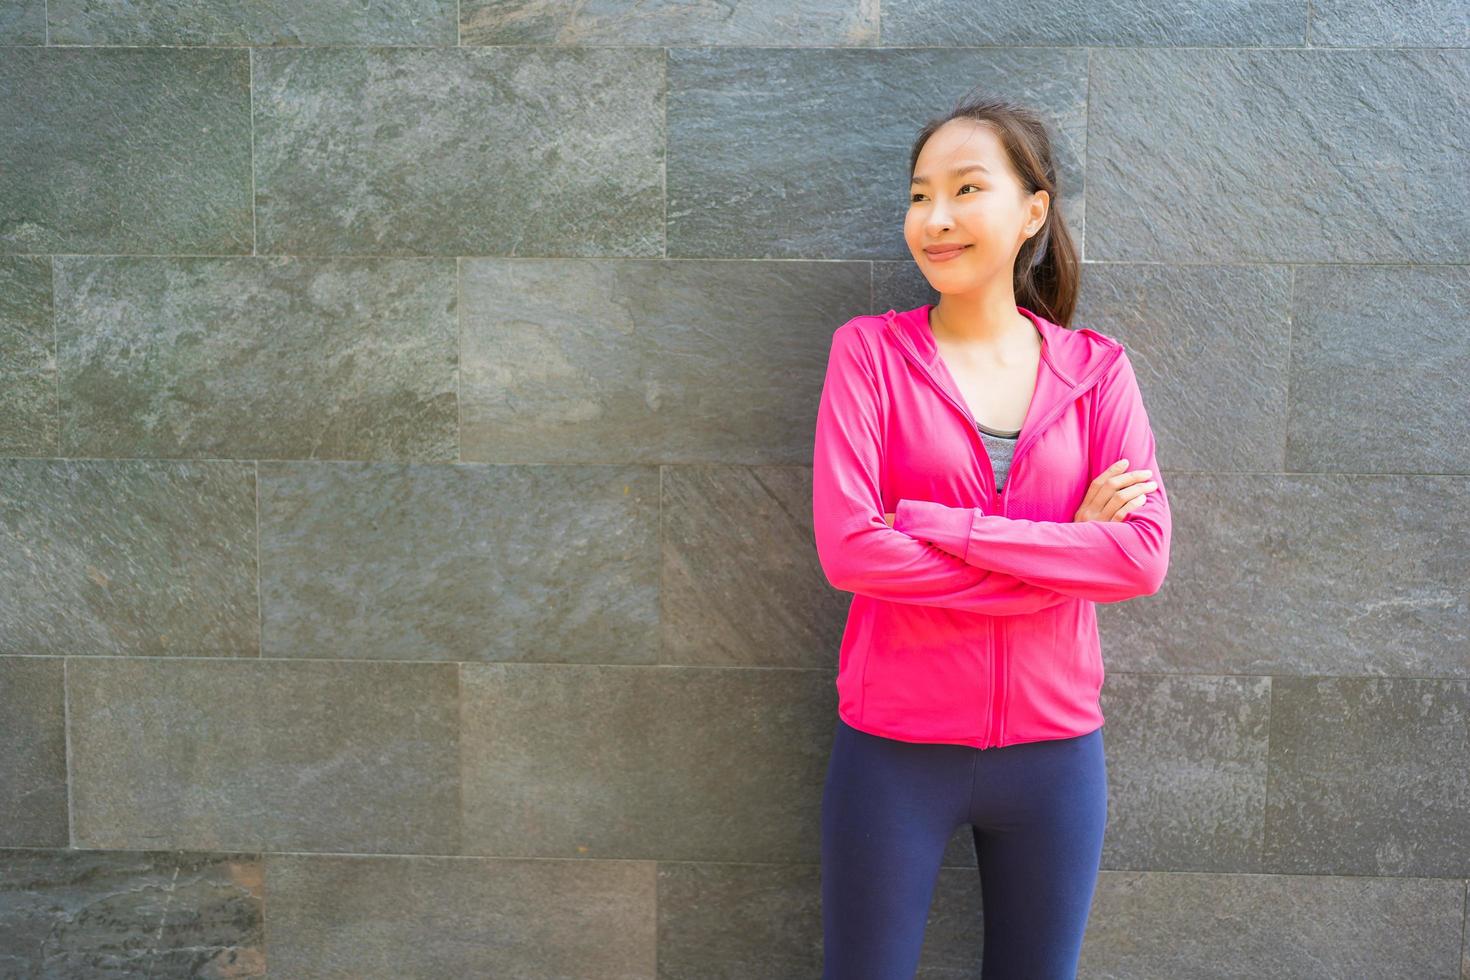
[811,304,1172,749]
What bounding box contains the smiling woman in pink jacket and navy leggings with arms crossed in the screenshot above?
[813,94,1172,980]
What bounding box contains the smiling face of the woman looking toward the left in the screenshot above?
[904,119,1050,292]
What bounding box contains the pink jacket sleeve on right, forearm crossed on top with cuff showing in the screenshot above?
[894,353,1173,602]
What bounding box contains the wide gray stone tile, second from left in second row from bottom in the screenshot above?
[68,657,460,854]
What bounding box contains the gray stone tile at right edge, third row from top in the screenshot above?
[1286,266,1470,473]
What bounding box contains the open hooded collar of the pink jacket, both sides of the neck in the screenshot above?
[882,303,1123,467]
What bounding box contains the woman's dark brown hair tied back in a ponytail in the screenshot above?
[908,98,1080,326]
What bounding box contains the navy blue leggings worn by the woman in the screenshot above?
[822,718,1107,980]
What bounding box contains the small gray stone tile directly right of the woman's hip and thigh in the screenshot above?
[1103,671,1272,871]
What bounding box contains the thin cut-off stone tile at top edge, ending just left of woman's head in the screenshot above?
[460,0,878,47]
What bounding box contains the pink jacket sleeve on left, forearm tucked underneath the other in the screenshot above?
[811,326,1070,616]
